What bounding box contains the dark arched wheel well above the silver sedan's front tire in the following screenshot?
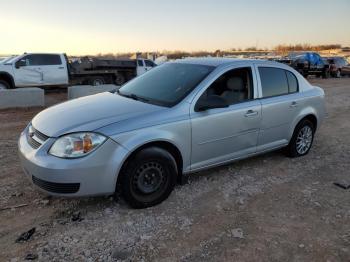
[117,141,183,183]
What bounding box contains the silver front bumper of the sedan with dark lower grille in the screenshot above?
[18,129,128,196]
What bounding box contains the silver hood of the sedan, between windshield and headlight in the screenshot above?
[32,92,163,137]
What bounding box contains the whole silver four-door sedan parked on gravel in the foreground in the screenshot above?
[18,58,325,208]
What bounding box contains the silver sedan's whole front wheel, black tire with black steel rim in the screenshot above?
[120,147,178,208]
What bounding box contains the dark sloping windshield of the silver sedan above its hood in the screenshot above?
[118,63,214,107]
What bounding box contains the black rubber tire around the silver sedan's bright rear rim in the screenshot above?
[286,119,315,157]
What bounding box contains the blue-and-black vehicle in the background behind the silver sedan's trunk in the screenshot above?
[291,52,330,78]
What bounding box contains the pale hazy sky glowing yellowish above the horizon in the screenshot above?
[0,0,350,55]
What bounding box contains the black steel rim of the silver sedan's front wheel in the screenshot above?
[133,162,164,194]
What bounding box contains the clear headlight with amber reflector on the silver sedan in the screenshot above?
[49,133,107,158]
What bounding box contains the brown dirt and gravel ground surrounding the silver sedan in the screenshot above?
[0,78,350,261]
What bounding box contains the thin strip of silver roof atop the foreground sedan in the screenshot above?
[174,57,285,67]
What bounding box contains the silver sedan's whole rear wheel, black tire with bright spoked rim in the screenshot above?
[287,119,315,157]
